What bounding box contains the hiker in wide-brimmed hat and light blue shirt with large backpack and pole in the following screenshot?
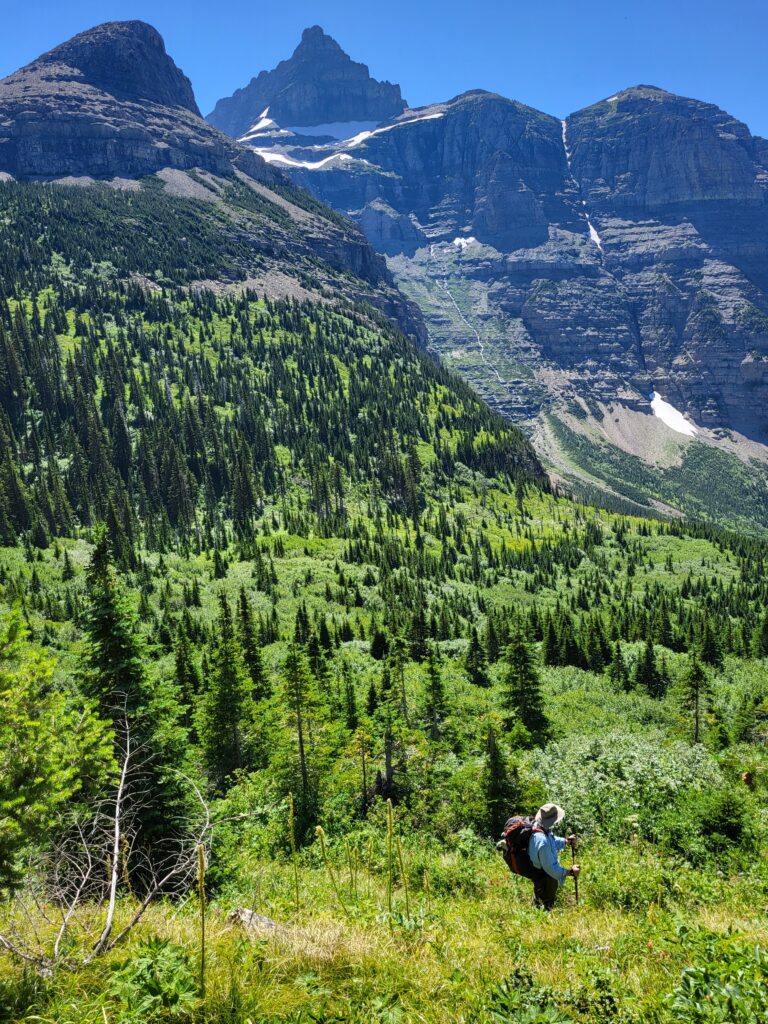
[497,804,580,910]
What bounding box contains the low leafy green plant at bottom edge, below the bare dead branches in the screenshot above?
[106,938,198,1024]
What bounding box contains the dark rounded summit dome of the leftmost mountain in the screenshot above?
[3,20,200,114]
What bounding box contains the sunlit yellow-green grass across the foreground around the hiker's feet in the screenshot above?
[0,829,768,1024]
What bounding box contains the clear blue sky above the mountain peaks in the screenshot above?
[0,0,768,136]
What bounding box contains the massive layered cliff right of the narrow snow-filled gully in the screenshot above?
[567,86,768,440]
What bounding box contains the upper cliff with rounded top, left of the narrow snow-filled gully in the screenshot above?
[287,92,577,253]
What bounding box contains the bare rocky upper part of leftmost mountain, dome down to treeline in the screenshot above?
[0,22,274,180]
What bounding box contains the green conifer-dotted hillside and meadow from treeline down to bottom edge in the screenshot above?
[0,176,768,1024]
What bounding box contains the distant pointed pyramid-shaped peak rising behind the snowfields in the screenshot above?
[208,26,406,138]
